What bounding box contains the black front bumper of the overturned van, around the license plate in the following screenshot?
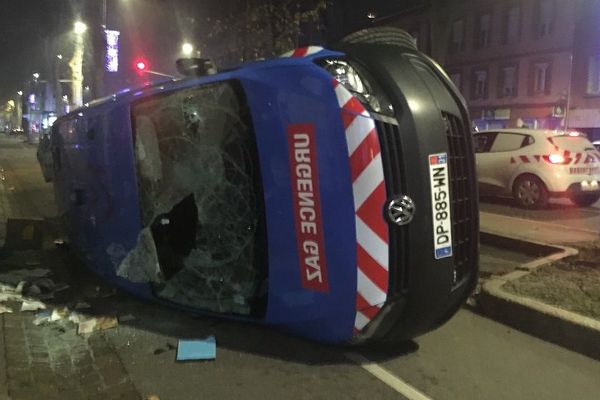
[340,44,479,342]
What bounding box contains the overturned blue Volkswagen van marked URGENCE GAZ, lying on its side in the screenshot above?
[49,29,478,344]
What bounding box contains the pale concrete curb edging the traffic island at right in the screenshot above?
[477,232,600,360]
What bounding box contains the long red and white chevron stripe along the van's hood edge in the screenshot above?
[333,80,389,333]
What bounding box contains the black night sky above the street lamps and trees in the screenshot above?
[0,0,423,104]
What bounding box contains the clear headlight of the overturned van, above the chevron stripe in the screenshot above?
[318,59,394,115]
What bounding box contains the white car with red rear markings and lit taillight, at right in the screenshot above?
[473,128,600,208]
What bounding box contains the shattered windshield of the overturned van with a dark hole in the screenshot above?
[125,81,266,314]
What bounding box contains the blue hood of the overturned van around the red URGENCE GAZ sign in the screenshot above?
[240,65,356,341]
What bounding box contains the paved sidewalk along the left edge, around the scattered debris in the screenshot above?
[0,136,141,400]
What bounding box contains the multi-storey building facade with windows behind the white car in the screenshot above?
[378,0,600,140]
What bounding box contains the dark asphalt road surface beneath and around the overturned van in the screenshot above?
[0,138,600,400]
